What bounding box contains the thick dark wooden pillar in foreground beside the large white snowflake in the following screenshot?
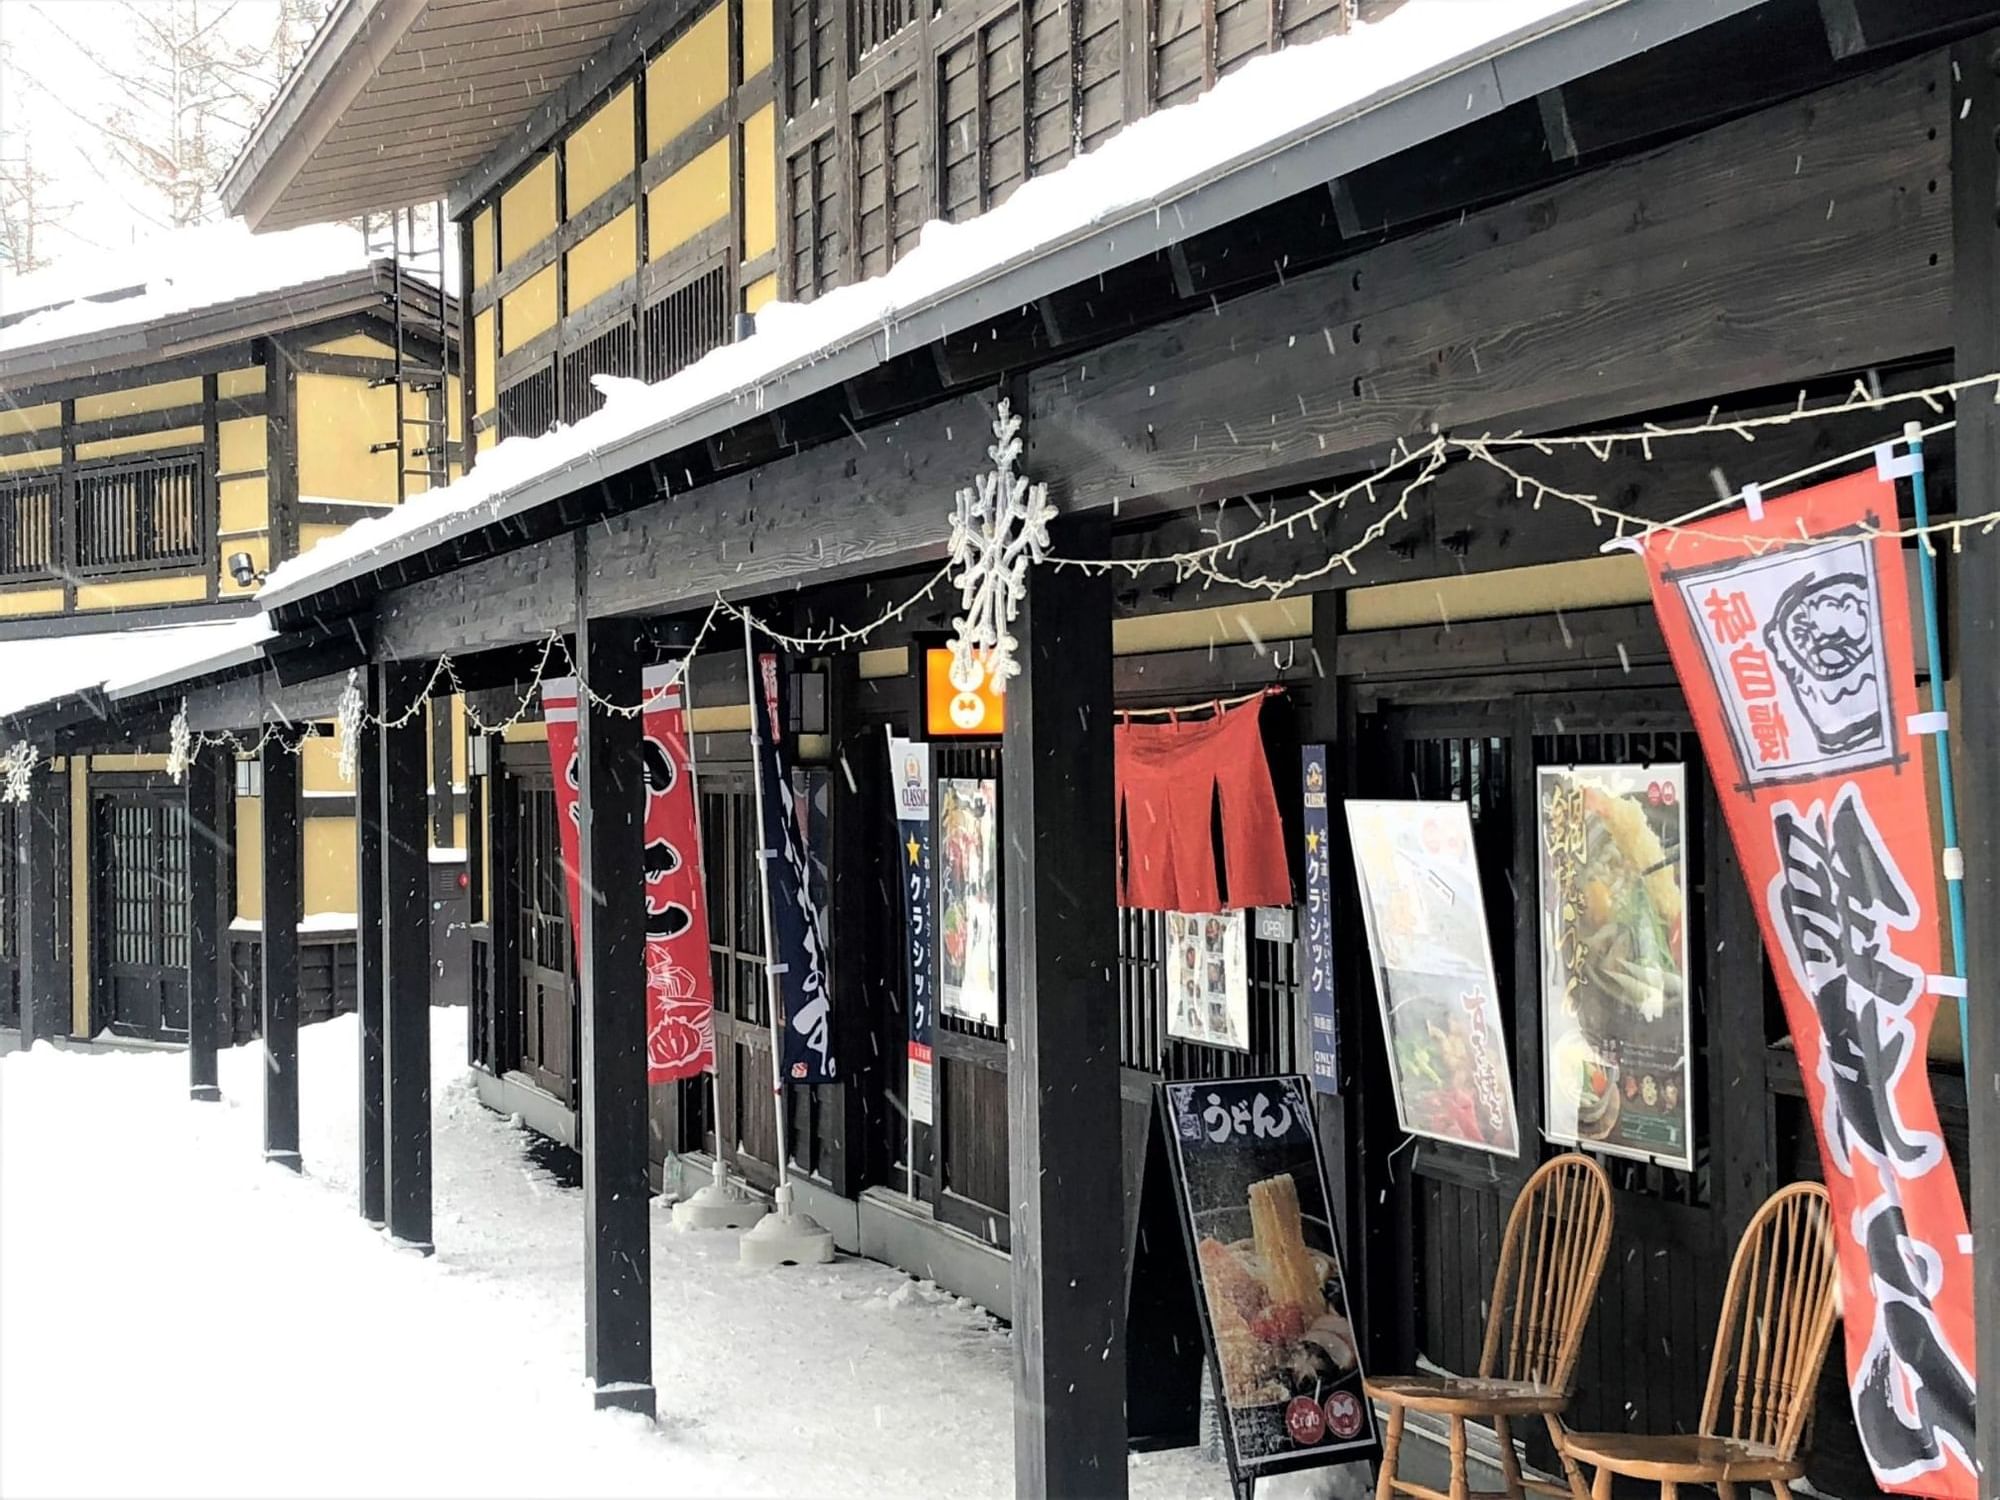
[1000,526,1126,1500]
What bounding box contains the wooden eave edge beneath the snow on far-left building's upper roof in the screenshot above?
[0,262,402,390]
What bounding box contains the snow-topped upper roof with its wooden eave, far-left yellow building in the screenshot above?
[0,220,388,384]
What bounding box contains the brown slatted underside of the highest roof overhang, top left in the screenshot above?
[222,0,664,230]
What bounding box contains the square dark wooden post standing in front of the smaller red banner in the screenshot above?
[576,608,654,1416]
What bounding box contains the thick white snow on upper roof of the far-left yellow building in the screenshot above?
[0,218,382,360]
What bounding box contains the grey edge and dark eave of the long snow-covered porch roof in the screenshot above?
[260,0,1764,640]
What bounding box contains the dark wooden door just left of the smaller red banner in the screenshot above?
[506,774,576,1104]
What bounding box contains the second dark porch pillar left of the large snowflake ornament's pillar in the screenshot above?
[376,662,432,1254]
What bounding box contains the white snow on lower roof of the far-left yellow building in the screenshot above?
[0,614,276,718]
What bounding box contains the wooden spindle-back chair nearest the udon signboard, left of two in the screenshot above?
[1366,1152,1612,1500]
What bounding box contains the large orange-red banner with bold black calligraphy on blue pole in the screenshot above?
[1644,474,1978,1500]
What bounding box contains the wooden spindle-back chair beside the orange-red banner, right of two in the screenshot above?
[1562,1182,1838,1500]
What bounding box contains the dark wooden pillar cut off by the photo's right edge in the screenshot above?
[1948,32,2000,1494]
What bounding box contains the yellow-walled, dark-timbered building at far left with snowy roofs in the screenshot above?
[0,224,464,1040]
